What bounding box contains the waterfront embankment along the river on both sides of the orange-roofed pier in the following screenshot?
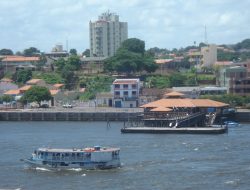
[0,107,250,123]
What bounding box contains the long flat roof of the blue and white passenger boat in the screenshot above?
[37,147,120,153]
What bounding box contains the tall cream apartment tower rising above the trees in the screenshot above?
[89,12,128,57]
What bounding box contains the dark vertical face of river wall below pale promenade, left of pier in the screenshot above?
[0,111,141,121]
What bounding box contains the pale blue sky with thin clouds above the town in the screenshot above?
[0,0,250,52]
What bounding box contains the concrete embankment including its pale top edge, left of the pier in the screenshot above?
[0,108,142,121]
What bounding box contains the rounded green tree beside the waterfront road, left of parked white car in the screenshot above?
[20,86,52,106]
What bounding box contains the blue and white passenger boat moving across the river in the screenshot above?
[24,146,121,169]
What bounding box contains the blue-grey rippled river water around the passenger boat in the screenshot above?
[0,122,250,190]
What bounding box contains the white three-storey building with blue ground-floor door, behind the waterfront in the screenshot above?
[112,79,140,108]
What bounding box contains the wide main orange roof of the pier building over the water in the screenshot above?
[141,98,228,108]
